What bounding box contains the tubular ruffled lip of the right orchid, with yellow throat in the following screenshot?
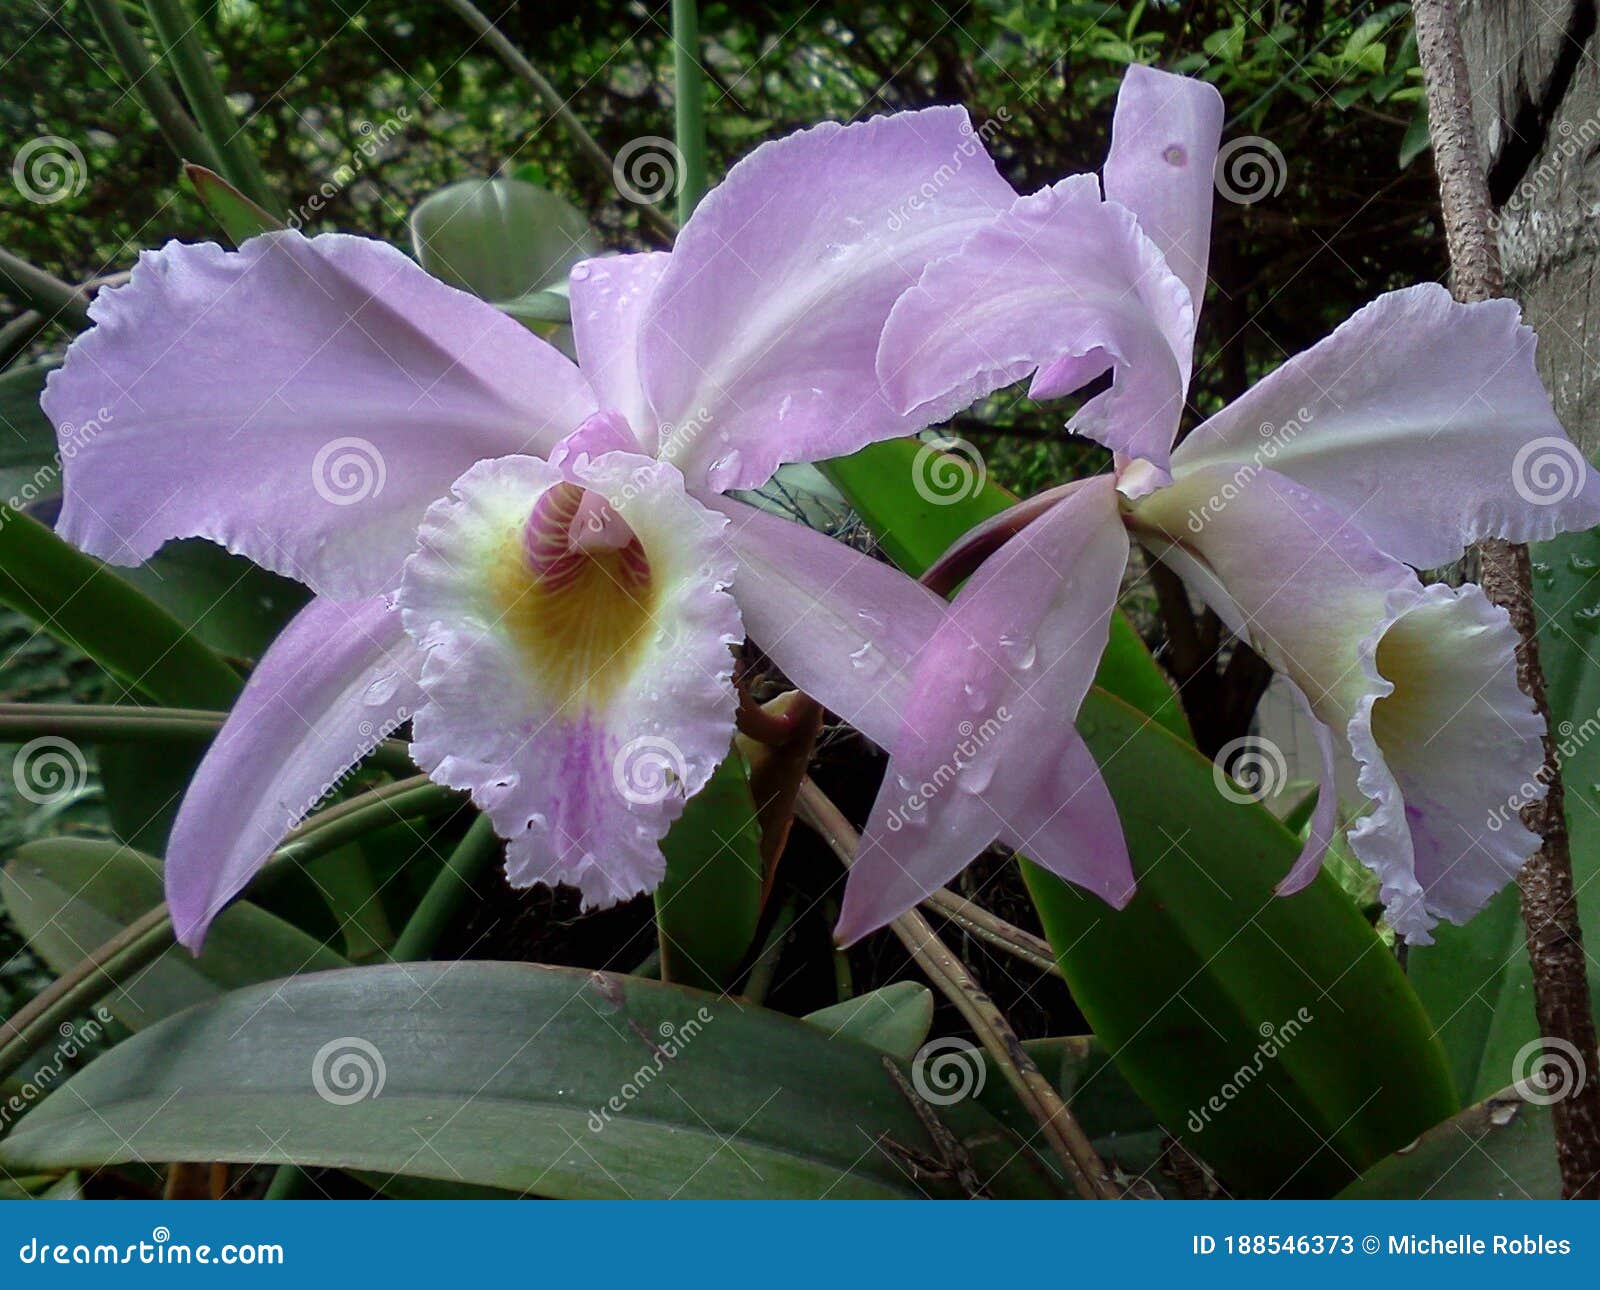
[1133,467,1542,944]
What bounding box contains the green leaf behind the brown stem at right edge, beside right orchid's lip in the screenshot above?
[1406,530,1600,1101]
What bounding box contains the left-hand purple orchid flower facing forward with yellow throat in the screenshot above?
[53,107,1016,947]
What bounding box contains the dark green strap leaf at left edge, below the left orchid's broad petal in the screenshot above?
[0,507,242,707]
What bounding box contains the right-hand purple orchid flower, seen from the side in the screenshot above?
[840,69,1600,944]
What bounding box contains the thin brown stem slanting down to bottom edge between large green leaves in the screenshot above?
[795,779,1117,1200]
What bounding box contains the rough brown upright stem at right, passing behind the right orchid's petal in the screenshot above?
[1411,0,1600,1199]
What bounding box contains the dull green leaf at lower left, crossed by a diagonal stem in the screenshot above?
[0,839,344,1031]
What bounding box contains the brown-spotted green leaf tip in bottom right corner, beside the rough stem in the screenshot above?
[1339,1088,1562,1200]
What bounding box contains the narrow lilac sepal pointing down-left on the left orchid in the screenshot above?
[166,595,421,952]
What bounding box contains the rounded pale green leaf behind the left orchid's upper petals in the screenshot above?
[411,179,598,307]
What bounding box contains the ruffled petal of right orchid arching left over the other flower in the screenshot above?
[877,174,1195,487]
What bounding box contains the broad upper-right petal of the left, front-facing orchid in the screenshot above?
[640,107,1014,491]
